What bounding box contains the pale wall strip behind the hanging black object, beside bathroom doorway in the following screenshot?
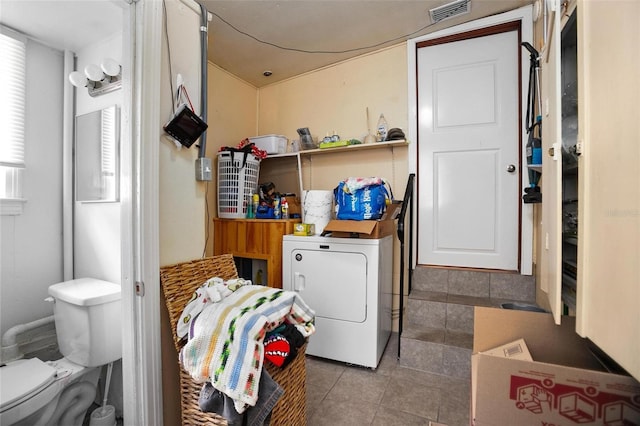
[158,0,205,266]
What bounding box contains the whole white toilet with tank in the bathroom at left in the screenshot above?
[0,278,122,426]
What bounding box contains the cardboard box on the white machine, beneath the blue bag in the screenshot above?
[322,204,400,238]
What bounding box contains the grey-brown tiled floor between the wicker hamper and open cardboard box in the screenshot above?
[307,333,471,426]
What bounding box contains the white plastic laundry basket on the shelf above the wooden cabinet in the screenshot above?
[218,151,260,219]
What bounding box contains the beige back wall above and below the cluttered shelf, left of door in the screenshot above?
[258,44,407,196]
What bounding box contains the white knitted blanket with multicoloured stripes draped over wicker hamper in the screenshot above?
[180,285,315,413]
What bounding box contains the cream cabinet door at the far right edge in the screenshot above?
[576,1,640,380]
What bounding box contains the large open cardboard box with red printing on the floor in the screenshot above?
[471,307,640,426]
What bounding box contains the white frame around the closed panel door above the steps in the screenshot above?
[407,6,534,275]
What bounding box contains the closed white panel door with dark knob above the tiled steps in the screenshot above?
[417,30,521,270]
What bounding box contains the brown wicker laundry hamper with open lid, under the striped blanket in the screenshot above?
[160,254,307,426]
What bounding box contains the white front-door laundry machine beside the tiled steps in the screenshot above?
[282,235,393,368]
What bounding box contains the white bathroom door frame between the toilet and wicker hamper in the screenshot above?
[120,0,163,426]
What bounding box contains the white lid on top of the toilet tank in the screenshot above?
[49,278,121,306]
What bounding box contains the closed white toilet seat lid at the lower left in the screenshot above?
[0,358,56,411]
